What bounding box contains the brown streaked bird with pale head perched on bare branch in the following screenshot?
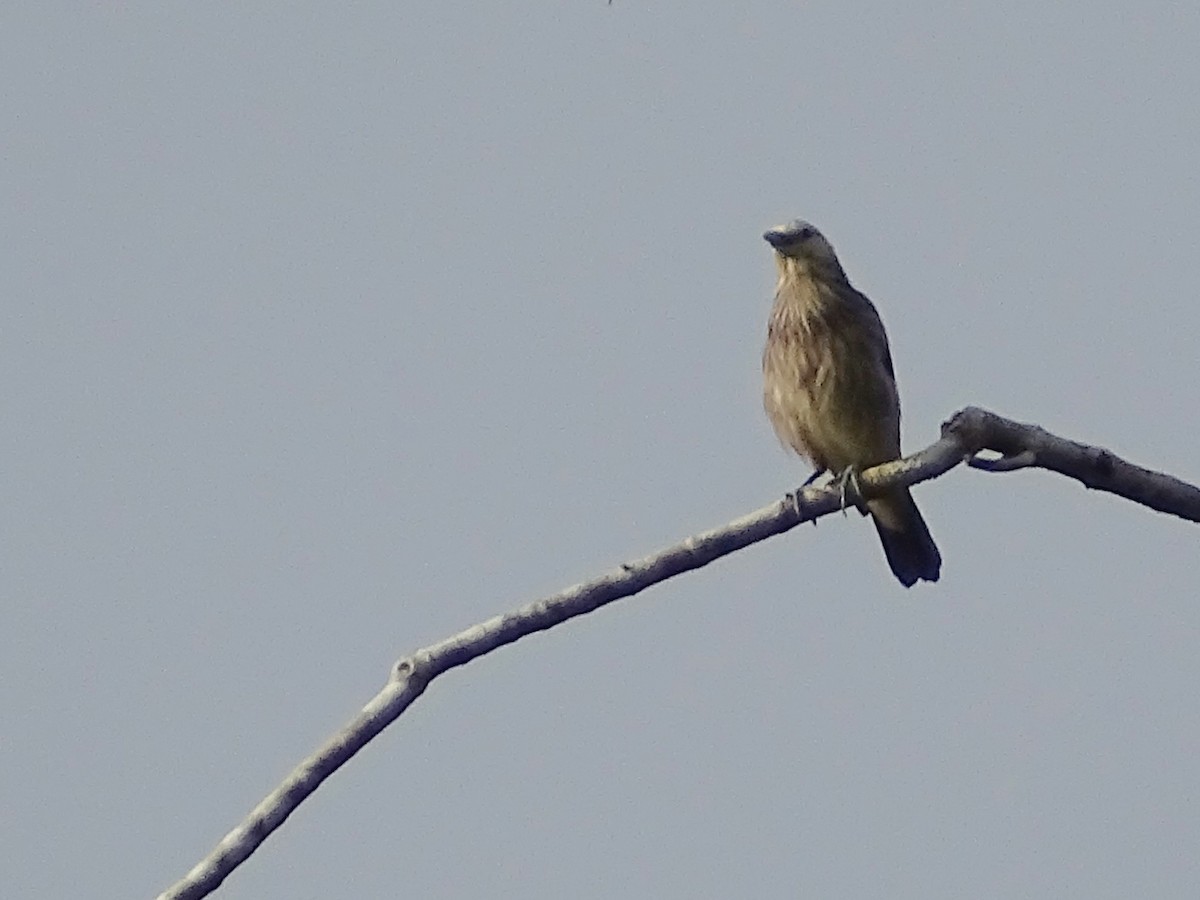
[762,220,942,587]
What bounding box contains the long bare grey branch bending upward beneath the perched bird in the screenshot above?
[160,407,1200,900]
